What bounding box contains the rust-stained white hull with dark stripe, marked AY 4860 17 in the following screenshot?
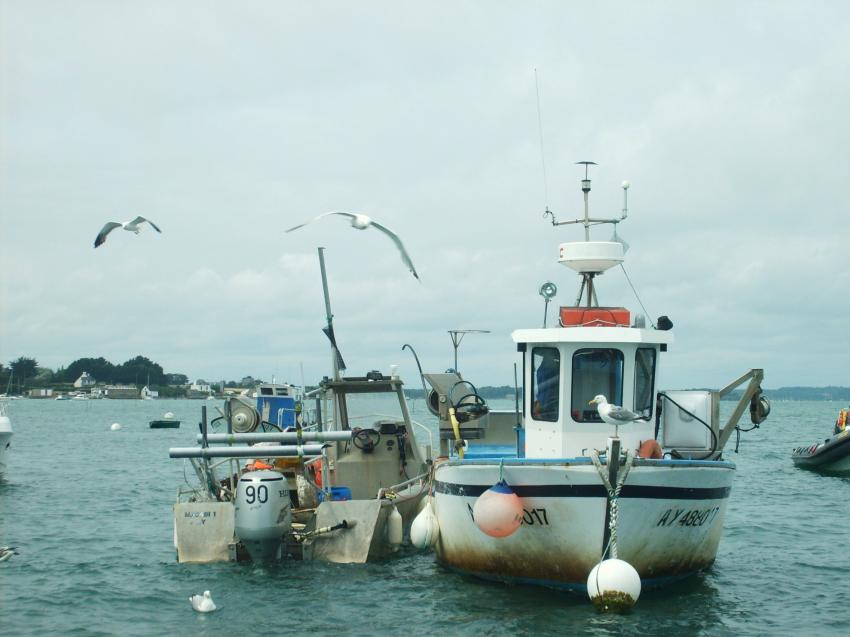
[434,458,735,590]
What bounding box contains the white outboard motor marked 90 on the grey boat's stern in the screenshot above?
[235,470,292,562]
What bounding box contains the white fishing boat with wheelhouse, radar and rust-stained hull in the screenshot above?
[415,162,769,607]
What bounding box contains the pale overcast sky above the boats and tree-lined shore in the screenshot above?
[0,0,850,389]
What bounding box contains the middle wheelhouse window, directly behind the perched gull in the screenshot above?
[570,348,623,422]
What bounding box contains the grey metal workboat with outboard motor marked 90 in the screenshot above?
[169,248,431,563]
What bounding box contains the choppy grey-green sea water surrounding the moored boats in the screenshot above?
[0,400,850,637]
